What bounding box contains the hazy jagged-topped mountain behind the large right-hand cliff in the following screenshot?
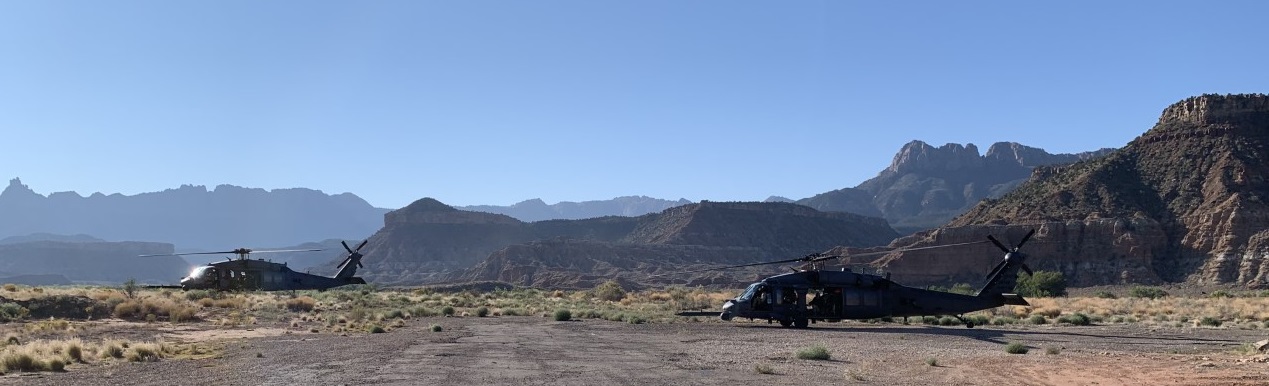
[797,141,1110,234]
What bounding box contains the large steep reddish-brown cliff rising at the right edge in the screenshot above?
[878,94,1269,287]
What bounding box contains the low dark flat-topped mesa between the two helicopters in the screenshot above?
[352,198,897,287]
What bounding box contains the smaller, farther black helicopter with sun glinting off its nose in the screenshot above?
[142,240,369,291]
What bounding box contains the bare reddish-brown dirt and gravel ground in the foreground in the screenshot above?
[0,316,1269,386]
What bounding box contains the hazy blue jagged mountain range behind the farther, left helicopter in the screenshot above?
[0,179,388,250]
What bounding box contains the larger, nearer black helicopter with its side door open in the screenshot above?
[679,230,1036,328]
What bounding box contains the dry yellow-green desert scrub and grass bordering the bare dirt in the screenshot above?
[0,283,1269,373]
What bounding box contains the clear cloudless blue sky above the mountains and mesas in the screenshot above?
[0,0,1269,208]
